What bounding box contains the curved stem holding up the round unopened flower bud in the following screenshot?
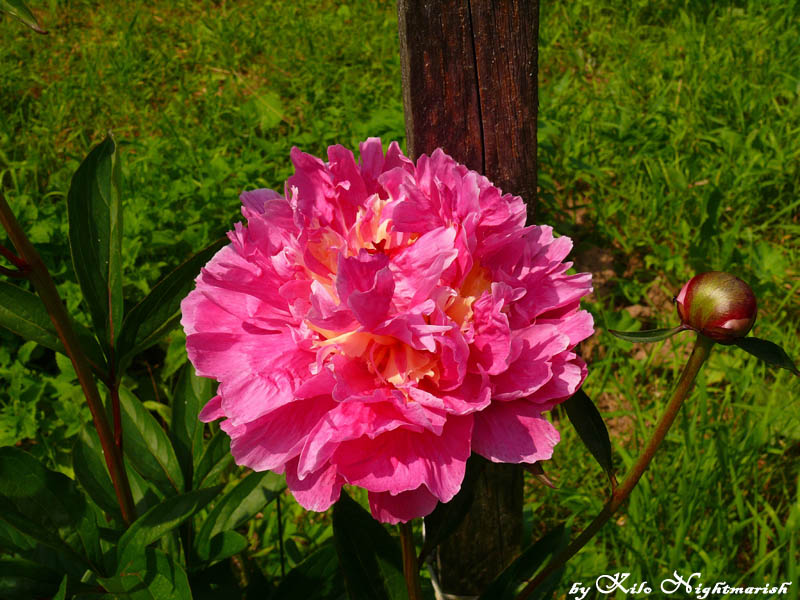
[517,333,714,600]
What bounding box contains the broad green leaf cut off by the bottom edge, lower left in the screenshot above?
[98,548,192,600]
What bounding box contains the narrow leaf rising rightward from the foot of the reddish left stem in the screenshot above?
[117,485,222,571]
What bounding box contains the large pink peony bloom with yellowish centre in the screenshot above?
[181,138,593,523]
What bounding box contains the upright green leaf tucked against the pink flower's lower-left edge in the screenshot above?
[170,363,214,482]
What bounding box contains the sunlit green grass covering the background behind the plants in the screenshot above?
[0,0,800,598]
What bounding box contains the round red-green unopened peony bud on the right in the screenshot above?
[676,271,757,344]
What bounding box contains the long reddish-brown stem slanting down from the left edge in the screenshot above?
[0,194,136,524]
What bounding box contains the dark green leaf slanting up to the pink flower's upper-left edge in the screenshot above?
[114,238,228,371]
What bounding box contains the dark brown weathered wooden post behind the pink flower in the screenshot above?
[398,0,539,596]
